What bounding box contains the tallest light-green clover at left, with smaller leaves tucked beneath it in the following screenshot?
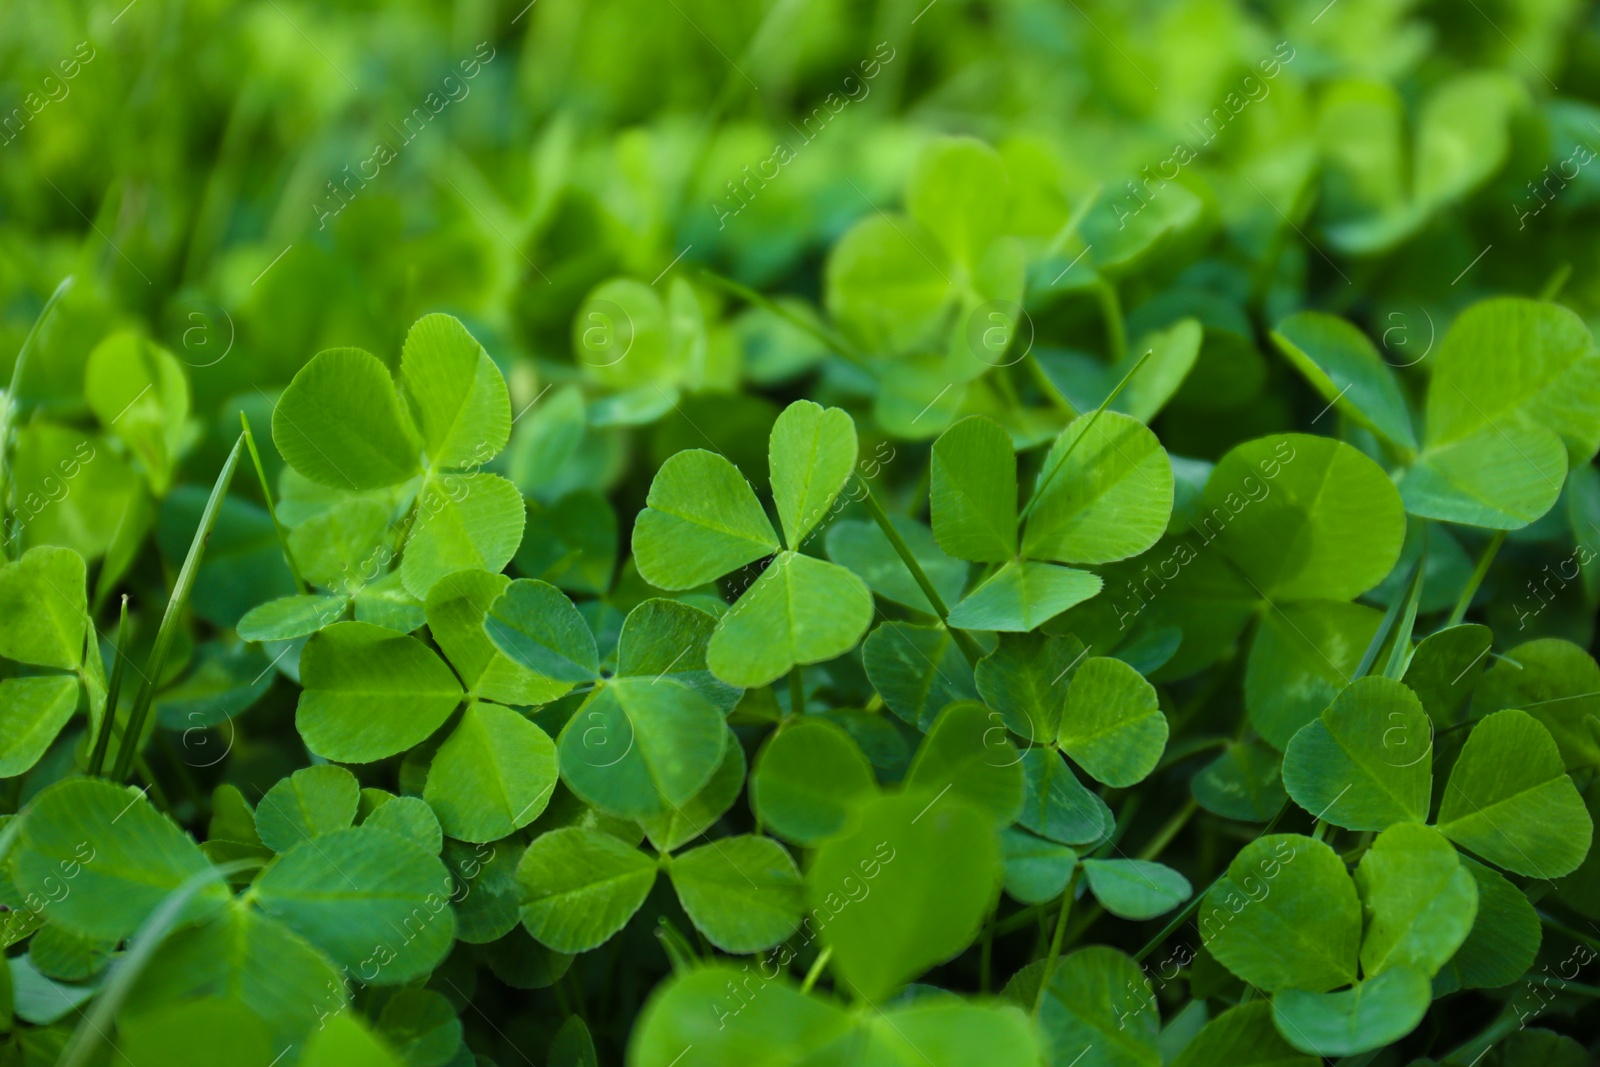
[240,315,526,640]
